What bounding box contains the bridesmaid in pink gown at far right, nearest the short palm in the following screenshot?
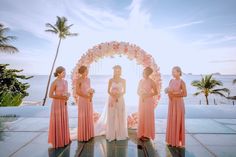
[165,66,187,147]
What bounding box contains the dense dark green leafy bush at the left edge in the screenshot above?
[0,64,32,106]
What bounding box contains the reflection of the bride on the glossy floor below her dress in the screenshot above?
[106,140,128,157]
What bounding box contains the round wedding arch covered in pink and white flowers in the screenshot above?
[72,41,162,128]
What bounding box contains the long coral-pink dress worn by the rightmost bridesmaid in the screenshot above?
[166,79,185,147]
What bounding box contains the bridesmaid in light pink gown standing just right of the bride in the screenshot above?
[138,67,158,140]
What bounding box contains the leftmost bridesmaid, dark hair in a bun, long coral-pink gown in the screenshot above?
[48,66,71,148]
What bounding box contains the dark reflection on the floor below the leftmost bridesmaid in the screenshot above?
[48,145,70,157]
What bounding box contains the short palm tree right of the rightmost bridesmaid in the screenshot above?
[191,74,230,105]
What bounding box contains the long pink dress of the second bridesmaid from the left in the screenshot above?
[77,78,94,141]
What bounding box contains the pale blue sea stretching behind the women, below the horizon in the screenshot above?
[24,75,236,108]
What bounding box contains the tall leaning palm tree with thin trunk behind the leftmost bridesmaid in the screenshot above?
[43,16,78,106]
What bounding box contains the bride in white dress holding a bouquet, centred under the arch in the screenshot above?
[106,65,128,141]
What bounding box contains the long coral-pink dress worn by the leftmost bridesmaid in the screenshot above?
[48,80,70,148]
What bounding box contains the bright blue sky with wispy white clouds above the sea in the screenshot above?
[0,0,236,75]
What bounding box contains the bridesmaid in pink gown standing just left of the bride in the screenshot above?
[76,66,94,142]
